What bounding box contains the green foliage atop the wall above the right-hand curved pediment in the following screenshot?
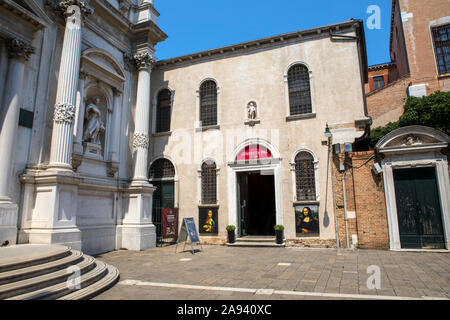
[370,91,450,147]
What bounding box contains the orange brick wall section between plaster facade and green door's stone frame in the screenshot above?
[333,151,389,249]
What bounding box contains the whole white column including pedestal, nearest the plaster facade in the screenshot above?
[117,51,156,250]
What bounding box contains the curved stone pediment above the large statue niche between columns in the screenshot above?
[81,49,125,91]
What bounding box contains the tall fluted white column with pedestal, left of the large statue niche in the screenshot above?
[19,0,92,250]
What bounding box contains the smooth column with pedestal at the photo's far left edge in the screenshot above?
[0,39,34,244]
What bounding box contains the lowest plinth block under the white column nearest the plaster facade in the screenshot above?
[117,224,156,251]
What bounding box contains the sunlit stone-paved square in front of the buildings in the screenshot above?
[95,246,450,300]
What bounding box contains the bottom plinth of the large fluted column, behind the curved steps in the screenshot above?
[19,228,81,250]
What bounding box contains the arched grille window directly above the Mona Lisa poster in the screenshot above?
[295,152,316,201]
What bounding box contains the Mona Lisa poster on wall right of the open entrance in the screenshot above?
[295,205,319,237]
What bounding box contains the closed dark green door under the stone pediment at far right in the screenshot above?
[394,168,445,249]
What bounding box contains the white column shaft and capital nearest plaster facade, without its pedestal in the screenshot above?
[133,52,154,184]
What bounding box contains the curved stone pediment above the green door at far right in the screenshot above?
[375,126,450,153]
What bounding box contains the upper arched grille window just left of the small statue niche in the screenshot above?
[200,80,217,127]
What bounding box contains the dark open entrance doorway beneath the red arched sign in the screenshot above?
[237,171,276,237]
